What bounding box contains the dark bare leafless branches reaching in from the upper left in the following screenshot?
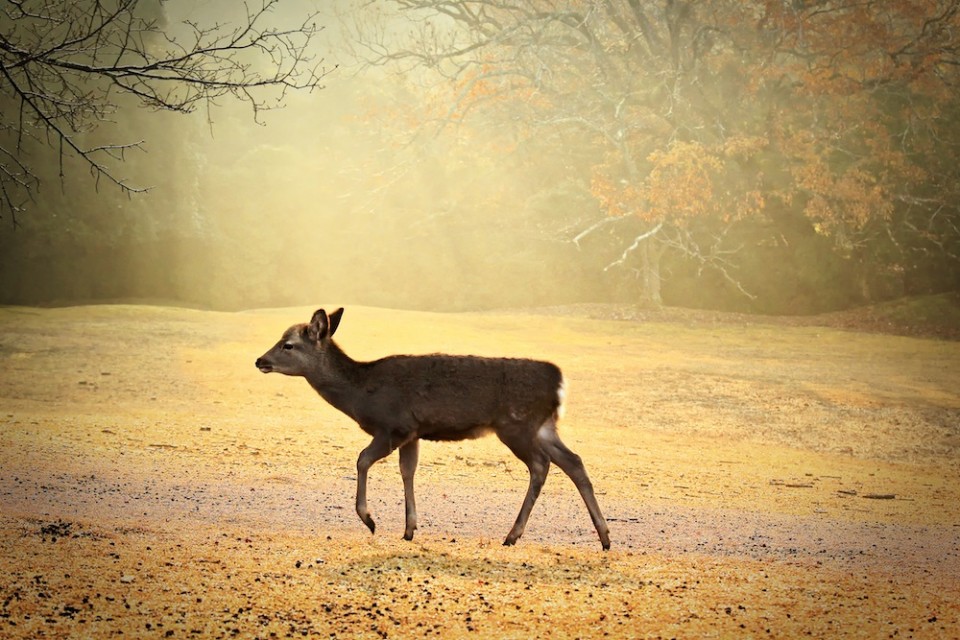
[0,0,327,225]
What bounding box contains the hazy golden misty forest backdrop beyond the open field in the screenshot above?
[0,0,960,314]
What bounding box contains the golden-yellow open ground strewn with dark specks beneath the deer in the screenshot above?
[0,306,960,639]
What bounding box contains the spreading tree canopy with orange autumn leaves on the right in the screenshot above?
[350,0,960,303]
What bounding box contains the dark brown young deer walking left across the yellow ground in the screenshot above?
[256,308,610,550]
